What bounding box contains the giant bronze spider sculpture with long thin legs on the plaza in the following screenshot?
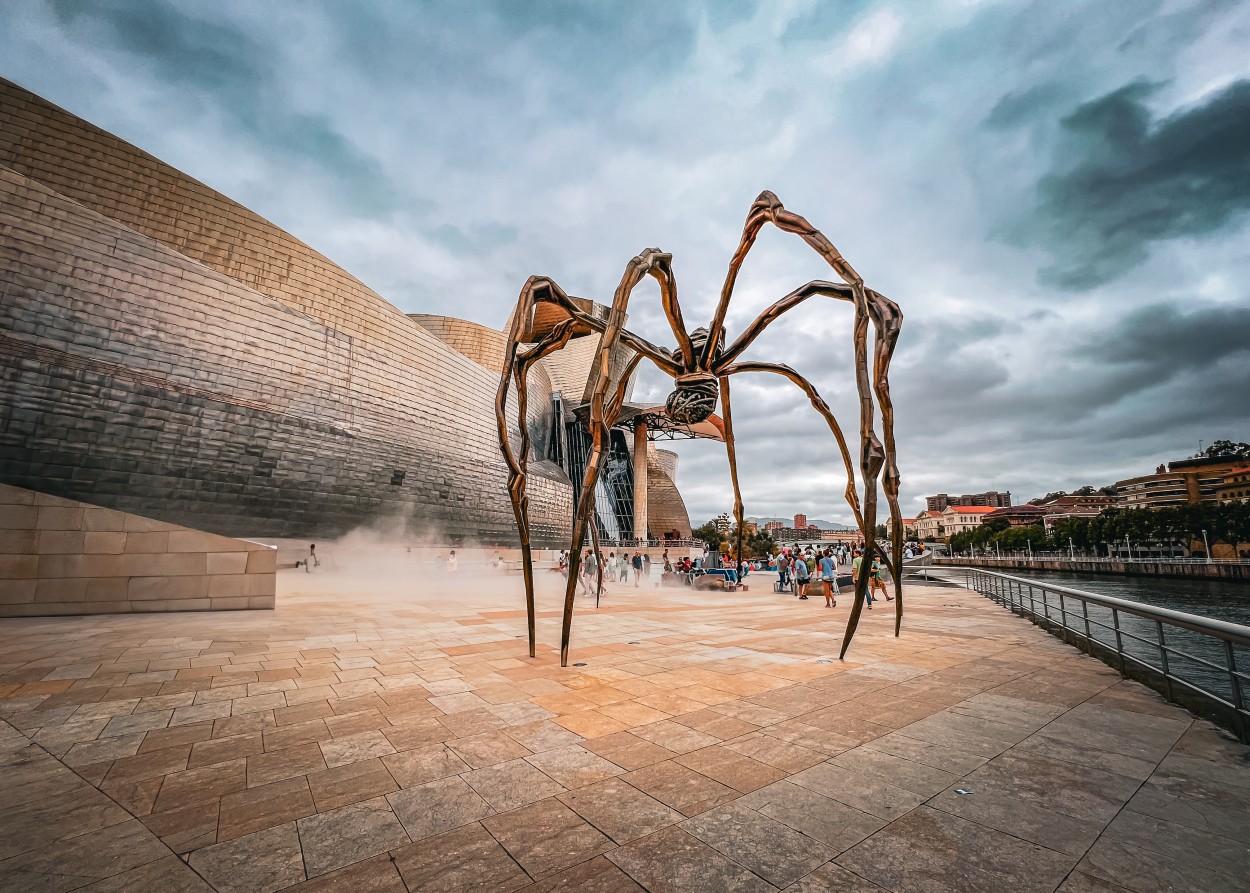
[495,191,903,667]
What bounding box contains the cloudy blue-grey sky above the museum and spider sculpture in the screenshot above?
[0,0,1250,523]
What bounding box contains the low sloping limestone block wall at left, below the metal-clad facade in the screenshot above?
[0,484,278,617]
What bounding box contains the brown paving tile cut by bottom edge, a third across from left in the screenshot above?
[393,822,530,893]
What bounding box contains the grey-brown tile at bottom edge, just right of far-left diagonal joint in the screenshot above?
[189,822,304,893]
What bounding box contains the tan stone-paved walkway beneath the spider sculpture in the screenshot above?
[0,568,1250,893]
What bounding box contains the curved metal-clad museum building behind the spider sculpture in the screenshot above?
[0,80,705,548]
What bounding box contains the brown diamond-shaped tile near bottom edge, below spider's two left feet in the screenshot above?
[483,799,613,878]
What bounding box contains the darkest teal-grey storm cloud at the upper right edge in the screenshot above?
[1038,80,1250,291]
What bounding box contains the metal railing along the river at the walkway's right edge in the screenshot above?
[941,568,1250,743]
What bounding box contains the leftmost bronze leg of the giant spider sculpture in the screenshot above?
[495,276,573,658]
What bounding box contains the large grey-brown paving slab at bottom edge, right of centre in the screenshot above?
[835,807,1074,893]
